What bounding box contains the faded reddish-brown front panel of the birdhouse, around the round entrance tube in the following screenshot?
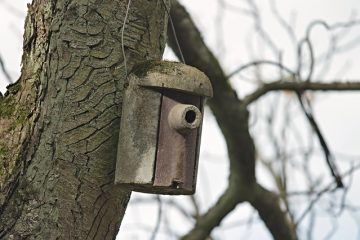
[154,91,202,194]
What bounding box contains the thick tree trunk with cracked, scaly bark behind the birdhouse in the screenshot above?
[0,0,167,239]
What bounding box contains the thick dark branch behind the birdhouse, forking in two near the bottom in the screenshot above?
[168,1,296,239]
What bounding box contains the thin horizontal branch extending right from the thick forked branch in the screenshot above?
[243,81,360,105]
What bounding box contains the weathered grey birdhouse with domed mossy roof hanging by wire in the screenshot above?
[115,61,213,195]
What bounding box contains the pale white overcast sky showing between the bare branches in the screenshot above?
[0,0,360,240]
